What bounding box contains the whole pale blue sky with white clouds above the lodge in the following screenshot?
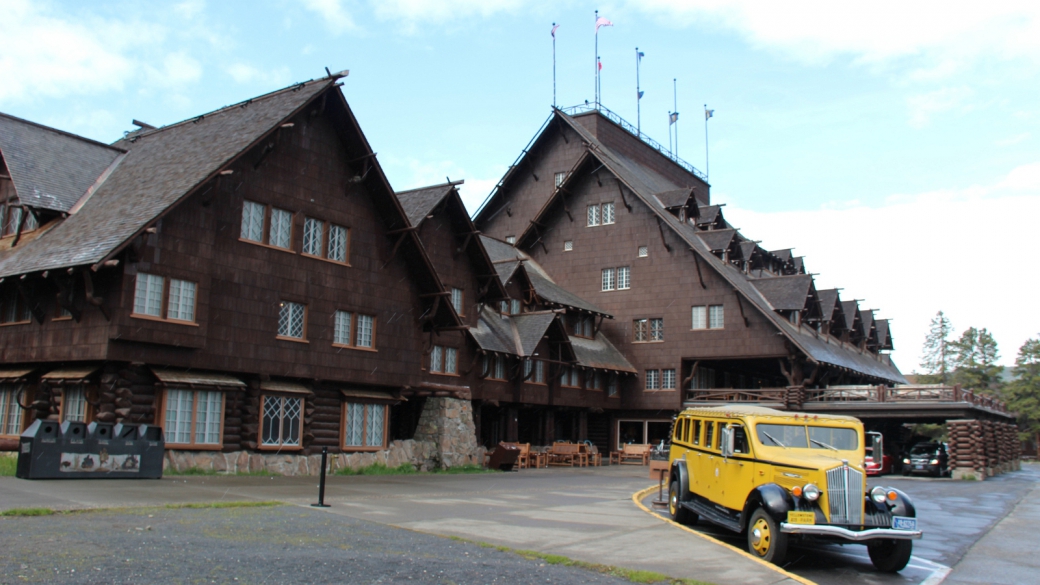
[0,0,1040,372]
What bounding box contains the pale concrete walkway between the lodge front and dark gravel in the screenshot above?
[0,466,796,584]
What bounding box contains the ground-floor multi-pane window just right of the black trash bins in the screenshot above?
[163,389,224,447]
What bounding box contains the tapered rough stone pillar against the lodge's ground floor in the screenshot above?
[415,398,482,468]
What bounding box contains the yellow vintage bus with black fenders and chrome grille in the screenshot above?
[669,405,921,573]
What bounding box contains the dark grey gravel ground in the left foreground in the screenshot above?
[0,506,630,585]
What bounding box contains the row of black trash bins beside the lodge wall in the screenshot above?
[16,421,165,480]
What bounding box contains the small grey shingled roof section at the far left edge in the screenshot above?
[0,113,123,211]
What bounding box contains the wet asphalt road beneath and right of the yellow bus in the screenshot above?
[648,465,1040,585]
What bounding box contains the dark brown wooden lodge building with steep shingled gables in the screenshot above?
[0,73,905,474]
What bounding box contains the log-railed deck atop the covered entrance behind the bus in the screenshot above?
[683,385,1015,422]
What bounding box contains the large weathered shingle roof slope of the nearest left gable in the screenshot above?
[0,79,335,277]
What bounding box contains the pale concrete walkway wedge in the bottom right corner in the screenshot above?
[943,476,1040,585]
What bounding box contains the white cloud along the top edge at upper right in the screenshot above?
[628,0,1040,72]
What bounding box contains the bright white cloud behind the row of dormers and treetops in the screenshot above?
[725,162,1040,372]
